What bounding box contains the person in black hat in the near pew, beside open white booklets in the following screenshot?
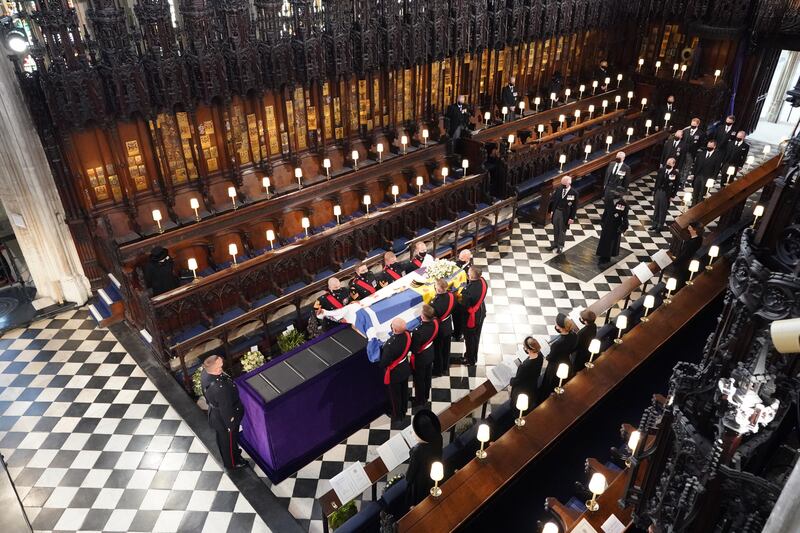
[405,409,442,508]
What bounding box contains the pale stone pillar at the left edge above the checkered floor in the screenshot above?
[0,56,90,304]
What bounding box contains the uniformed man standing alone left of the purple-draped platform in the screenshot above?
[200,355,247,469]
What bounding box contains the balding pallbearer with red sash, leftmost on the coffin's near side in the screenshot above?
[379,318,411,422]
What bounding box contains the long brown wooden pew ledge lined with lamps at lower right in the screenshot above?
[398,259,730,533]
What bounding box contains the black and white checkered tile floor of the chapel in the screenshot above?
[0,139,776,532]
